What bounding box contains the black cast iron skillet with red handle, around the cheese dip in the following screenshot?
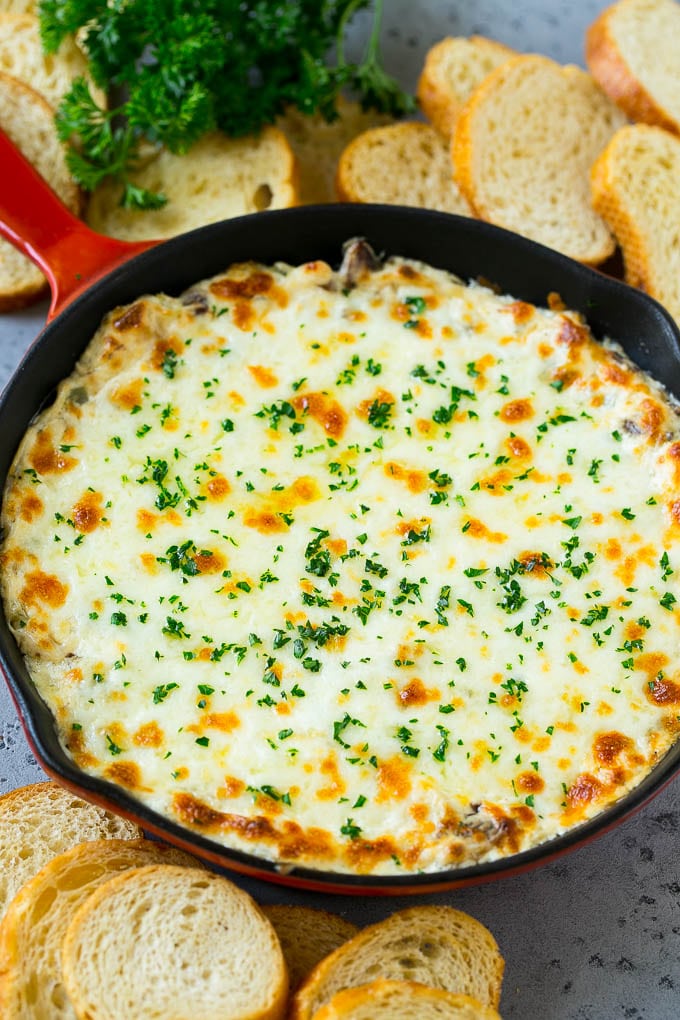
[0,132,680,895]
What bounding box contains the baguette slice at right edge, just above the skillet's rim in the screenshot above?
[590,124,680,324]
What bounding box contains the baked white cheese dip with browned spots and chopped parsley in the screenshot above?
[1,244,680,874]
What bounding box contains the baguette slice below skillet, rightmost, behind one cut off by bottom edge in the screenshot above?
[291,907,504,1020]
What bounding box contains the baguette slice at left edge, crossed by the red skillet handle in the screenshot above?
[0,71,81,312]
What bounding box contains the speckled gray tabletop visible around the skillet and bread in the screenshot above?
[0,0,680,1020]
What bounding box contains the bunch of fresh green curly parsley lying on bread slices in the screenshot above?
[40,0,413,209]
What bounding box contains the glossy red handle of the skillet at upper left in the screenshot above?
[0,131,158,321]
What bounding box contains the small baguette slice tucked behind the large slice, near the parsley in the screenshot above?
[417,36,517,140]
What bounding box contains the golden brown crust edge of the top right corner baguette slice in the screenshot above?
[585,5,680,134]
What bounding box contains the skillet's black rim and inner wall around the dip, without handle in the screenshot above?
[0,204,680,895]
